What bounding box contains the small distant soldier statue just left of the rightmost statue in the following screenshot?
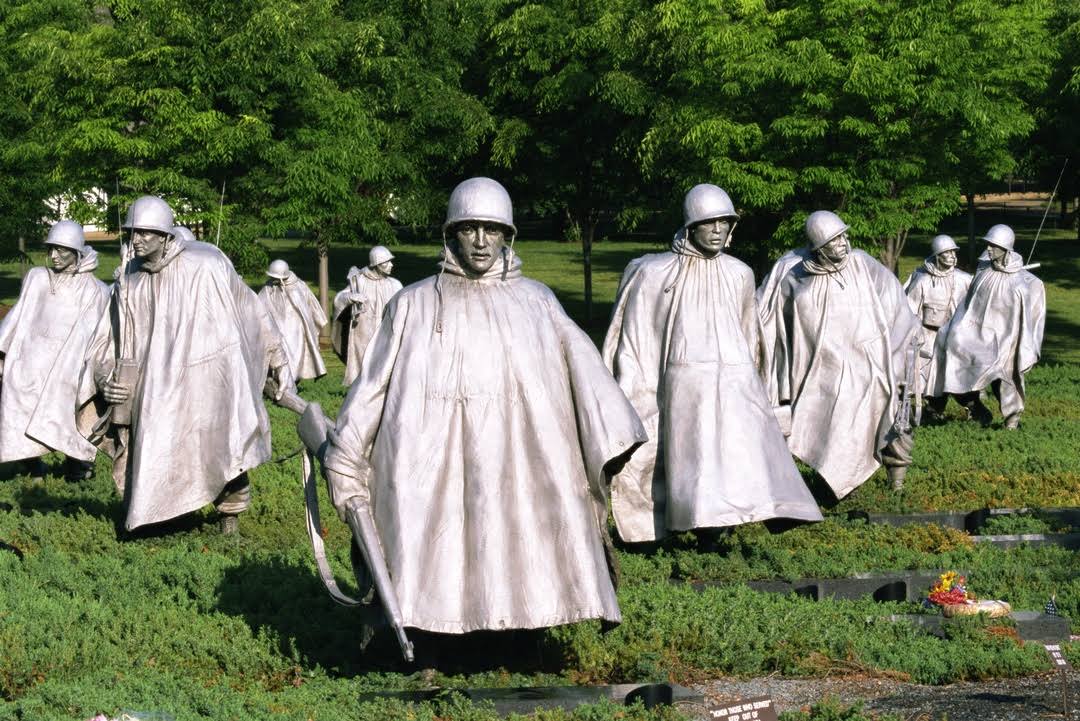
[904,235,971,423]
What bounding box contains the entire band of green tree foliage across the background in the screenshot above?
[0,0,1067,276]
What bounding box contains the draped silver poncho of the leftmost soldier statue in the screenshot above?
[0,248,109,463]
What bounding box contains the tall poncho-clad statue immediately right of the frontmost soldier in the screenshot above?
[604,183,822,541]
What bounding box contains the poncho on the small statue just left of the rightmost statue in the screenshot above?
[904,256,971,395]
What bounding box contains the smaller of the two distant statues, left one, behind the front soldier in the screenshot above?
[259,259,326,381]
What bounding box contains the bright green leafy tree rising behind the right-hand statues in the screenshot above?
[644,0,1048,269]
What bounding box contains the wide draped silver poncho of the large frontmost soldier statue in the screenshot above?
[325,248,646,634]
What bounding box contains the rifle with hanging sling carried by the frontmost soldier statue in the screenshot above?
[267,381,415,662]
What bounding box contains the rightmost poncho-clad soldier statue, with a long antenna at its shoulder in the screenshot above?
[935,226,1047,430]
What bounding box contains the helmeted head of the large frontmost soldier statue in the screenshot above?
[443,178,517,275]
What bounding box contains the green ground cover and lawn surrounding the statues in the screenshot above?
[0,227,1080,721]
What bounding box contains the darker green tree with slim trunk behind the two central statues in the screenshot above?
[486,0,652,322]
